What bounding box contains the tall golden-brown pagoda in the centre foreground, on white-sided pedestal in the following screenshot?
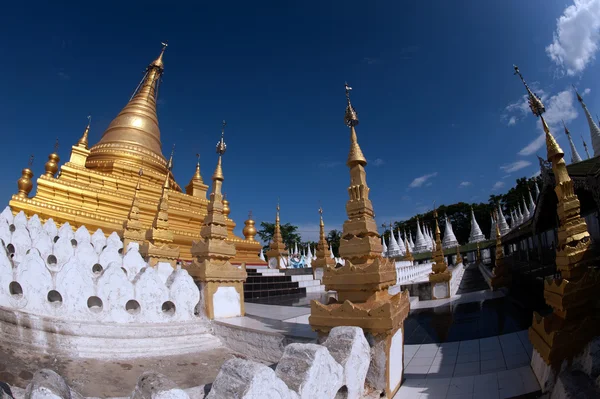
[309,84,410,398]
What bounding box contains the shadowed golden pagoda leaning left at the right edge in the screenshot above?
[514,66,600,376]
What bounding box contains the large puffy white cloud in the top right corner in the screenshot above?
[546,0,600,76]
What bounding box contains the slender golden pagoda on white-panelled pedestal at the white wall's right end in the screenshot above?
[188,126,247,319]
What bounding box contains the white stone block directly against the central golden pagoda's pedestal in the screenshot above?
[323,327,371,399]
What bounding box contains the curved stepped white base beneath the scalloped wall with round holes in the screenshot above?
[0,307,222,359]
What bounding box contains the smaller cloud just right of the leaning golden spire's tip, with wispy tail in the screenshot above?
[519,88,580,156]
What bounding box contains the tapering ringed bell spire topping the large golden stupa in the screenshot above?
[86,43,167,174]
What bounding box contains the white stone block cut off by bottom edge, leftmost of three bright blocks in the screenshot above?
[206,358,298,399]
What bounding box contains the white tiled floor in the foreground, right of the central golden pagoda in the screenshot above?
[394,330,540,399]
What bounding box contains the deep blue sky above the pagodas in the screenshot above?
[0,0,600,239]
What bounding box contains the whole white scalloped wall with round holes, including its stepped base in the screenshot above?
[0,208,221,358]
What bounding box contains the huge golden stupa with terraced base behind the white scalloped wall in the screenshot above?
[10,44,266,265]
